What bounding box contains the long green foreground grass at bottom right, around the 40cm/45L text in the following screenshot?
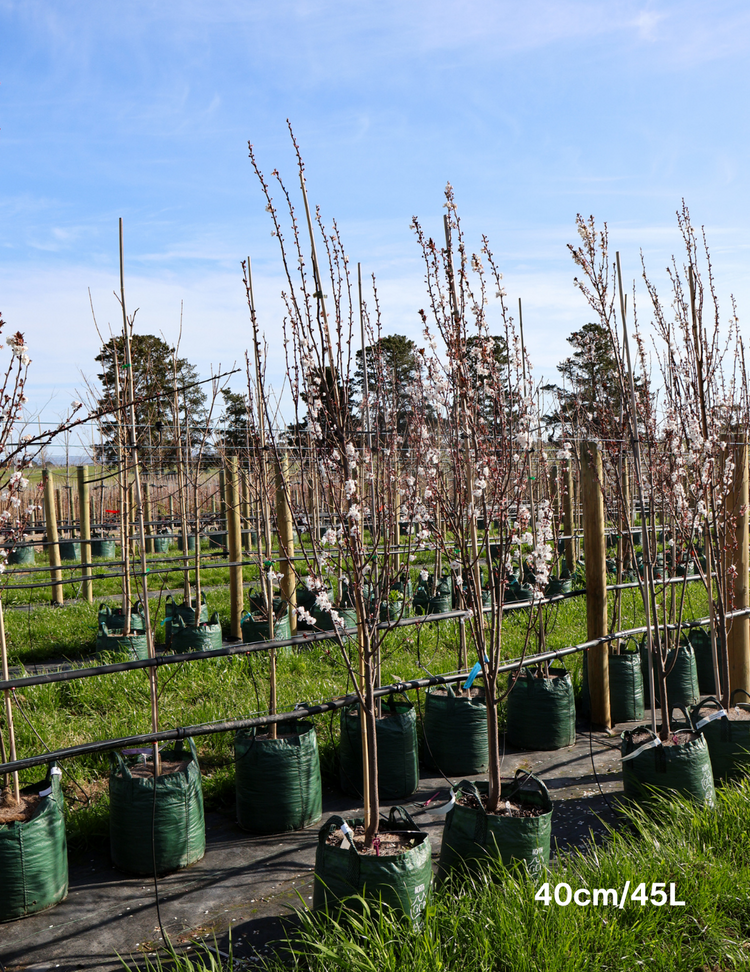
[264,781,750,972]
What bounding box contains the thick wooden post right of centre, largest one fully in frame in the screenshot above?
[581,442,612,729]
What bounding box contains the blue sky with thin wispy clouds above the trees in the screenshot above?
[0,0,750,448]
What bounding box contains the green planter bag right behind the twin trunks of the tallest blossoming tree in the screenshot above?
[339,696,419,800]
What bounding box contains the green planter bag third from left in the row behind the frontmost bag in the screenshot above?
[234,722,323,834]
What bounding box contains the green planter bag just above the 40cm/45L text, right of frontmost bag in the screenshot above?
[438,770,552,881]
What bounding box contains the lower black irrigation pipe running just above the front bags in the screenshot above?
[0,608,750,774]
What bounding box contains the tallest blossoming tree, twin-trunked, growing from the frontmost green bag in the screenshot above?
[249,133,426,845]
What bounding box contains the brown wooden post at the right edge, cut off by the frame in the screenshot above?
[727,432,750,699]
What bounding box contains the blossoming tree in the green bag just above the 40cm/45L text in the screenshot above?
[412,185,554,812]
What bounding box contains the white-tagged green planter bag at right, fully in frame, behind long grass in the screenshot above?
[621,726,716,807]
